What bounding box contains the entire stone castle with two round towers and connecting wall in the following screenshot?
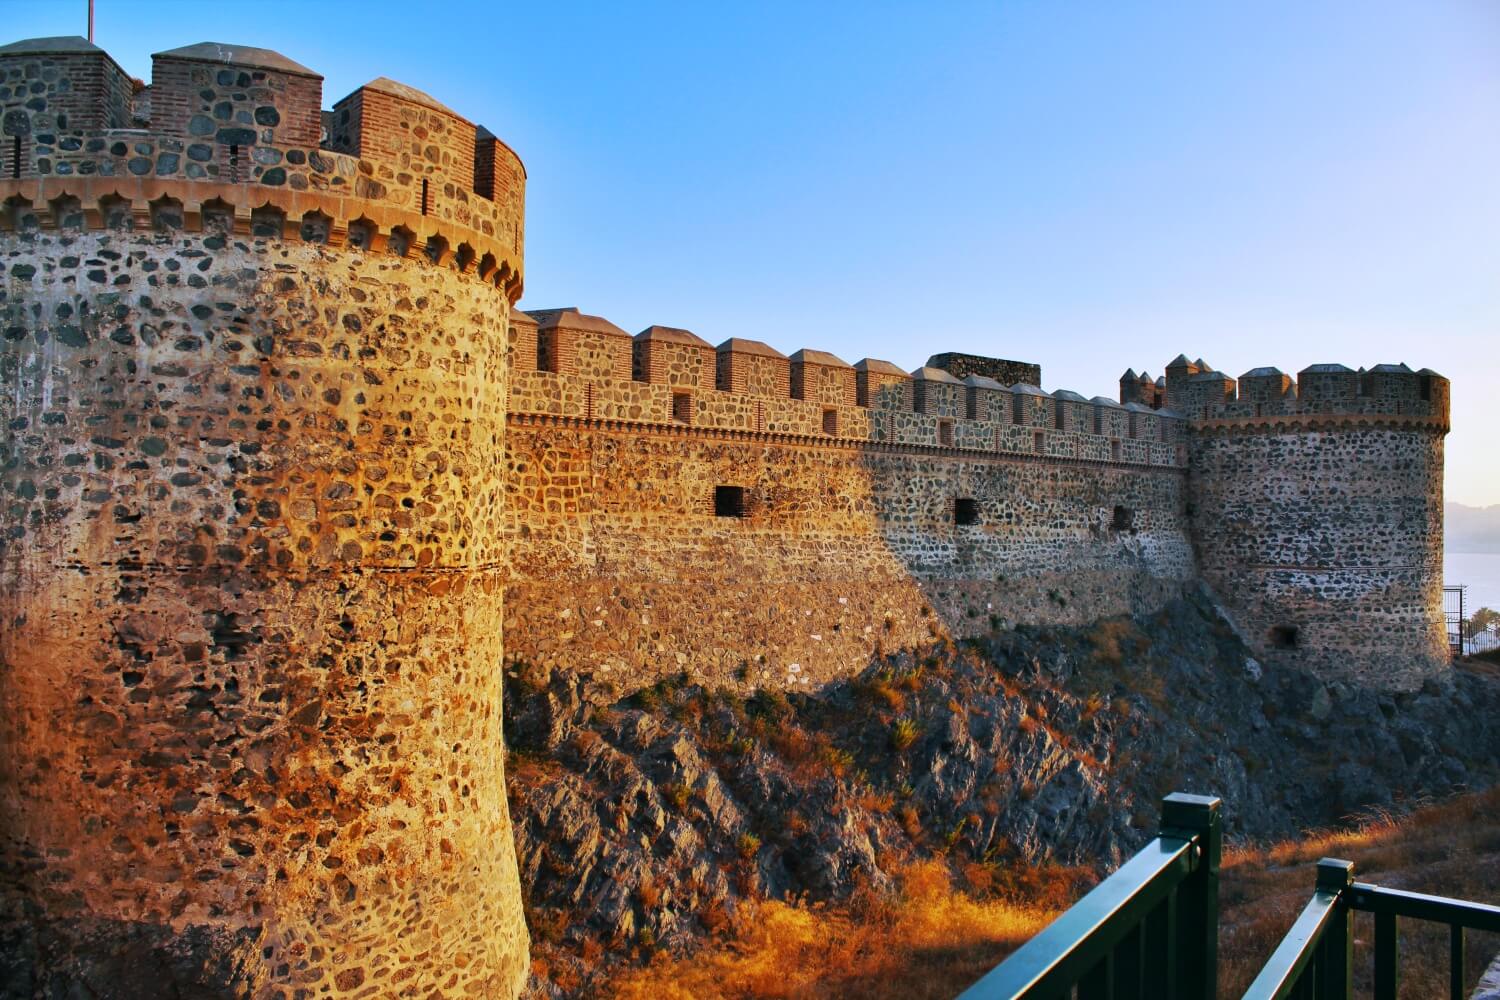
[0,37,1448,997]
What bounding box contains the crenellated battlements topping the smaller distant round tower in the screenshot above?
[1121,355,1449,429]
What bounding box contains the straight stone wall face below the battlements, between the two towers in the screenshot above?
[506,414,1193,690]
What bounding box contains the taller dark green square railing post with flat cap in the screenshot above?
[1161,792,1224,1000]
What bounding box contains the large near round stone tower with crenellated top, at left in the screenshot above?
[0,39,528,999]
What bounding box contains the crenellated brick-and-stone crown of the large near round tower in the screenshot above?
[0,37,525,297]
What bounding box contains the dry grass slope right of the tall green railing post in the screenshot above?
[1220,789,1500,1000]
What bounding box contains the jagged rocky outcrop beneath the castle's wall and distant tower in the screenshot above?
[507,594,1500,990]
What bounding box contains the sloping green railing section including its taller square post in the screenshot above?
[960,792,1223,1000]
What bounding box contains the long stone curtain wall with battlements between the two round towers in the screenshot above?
[506,309,1194,690]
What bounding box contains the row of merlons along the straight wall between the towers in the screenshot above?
[507,307,1185,466]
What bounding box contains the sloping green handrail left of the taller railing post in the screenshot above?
[959,835,1199,1000]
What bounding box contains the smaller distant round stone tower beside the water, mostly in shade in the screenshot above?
[1188,364,1449,690]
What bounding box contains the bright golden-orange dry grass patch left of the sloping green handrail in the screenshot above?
[608,861,1085,1000]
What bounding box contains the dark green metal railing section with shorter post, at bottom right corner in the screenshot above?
[1245,858,1500,1000]
